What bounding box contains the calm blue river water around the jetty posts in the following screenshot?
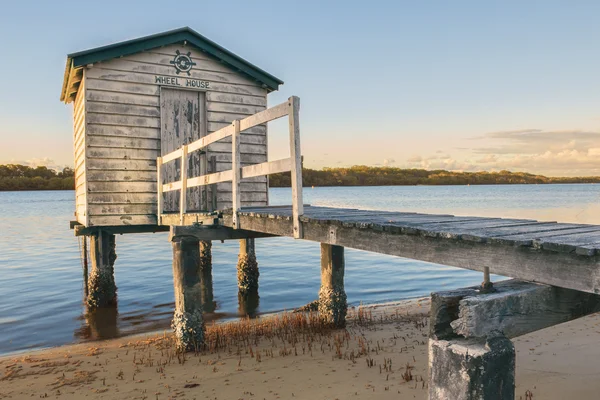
[0,184,600,354]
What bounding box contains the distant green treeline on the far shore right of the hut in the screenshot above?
[269,165,600,187]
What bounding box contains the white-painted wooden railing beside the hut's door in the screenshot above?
[156,96,304,238]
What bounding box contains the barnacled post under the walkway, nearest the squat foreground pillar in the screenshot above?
[319,243,348,327]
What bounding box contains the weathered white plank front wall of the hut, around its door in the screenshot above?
[76,45,267,226]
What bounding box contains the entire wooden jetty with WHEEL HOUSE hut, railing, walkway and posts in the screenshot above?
[61,28,600,399]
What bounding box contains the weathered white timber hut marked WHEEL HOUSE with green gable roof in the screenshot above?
[61,27,283,231]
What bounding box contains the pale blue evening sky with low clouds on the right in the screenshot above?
[0,0,600,176]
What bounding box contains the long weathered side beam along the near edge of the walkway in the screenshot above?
[223,213,600,293]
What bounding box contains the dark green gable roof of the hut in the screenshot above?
[60,26,283,103]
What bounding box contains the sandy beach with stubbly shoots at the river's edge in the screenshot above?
[0,299,600,400]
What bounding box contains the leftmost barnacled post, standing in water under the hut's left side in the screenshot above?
[86,231,117,310]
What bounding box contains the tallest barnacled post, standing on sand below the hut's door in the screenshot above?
[172,236,204,351]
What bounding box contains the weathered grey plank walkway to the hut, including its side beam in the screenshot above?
[162,205,600,293]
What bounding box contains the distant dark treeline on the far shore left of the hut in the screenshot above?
[0,164,75,191]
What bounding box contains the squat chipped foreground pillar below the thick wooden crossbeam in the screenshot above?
[429,335,515,400]
